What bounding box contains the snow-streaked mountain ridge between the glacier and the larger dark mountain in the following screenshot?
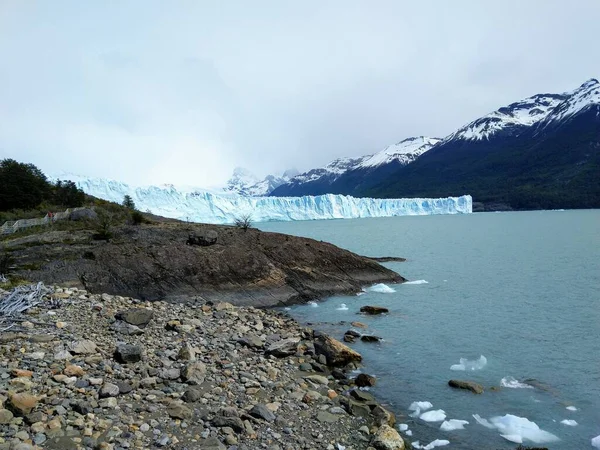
[270,136,440,196]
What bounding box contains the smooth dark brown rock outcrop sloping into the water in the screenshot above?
[3,223,404,307]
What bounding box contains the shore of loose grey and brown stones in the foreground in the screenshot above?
[0,287,410,450]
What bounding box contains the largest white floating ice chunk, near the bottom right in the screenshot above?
[473,414,559,444]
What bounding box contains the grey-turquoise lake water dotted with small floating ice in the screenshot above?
[258,210,600,450]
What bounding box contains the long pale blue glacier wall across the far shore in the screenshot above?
[73,177,473,224]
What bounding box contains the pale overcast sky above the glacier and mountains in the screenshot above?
[0,0,600,187]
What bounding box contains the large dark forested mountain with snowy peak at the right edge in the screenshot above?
[366,80,600,209]
